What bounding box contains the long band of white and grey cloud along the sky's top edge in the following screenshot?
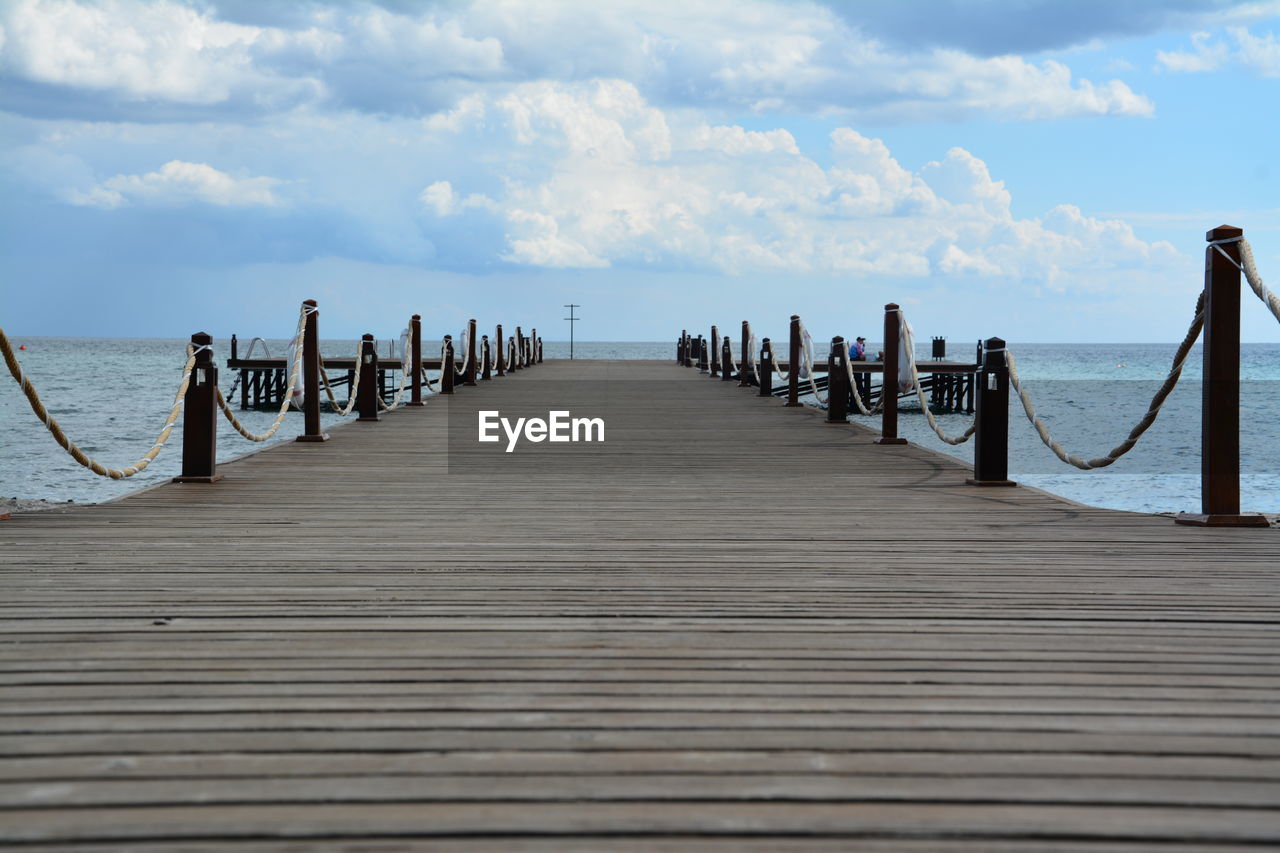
[0,0,1153,122]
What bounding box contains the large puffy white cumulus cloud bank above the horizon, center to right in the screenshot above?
[422,81,1181,280]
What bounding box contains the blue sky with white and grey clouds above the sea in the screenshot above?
[0,0,1280,343]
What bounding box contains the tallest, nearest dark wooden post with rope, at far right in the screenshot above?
[1174,225,1267,528]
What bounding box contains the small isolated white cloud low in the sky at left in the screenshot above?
[67,160,282,209]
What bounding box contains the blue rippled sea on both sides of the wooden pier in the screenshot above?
[0,337,1280,512]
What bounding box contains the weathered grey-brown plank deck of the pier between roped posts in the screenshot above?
[0,361,1280,853]
